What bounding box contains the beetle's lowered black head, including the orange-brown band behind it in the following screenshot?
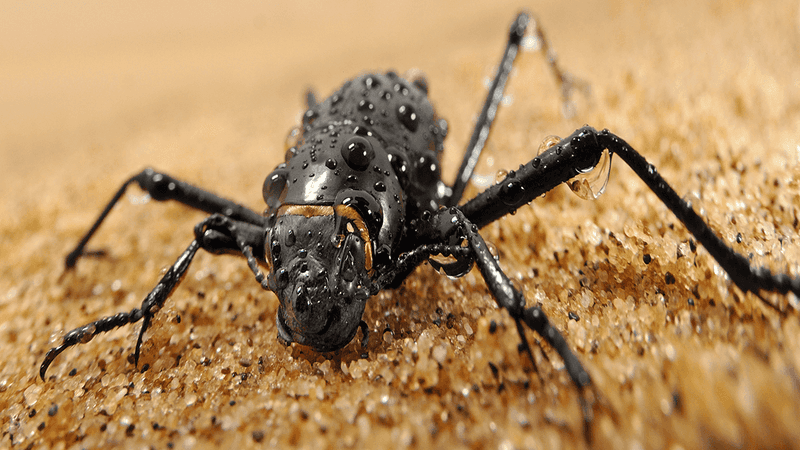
[266,205,372,351]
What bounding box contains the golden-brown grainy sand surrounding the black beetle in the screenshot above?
[0,0,800,449]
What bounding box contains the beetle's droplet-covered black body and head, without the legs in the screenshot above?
[264,72,445,351]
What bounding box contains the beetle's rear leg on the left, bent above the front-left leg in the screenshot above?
[65,168,266,269]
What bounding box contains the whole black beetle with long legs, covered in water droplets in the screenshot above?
[39,13,800,436]
